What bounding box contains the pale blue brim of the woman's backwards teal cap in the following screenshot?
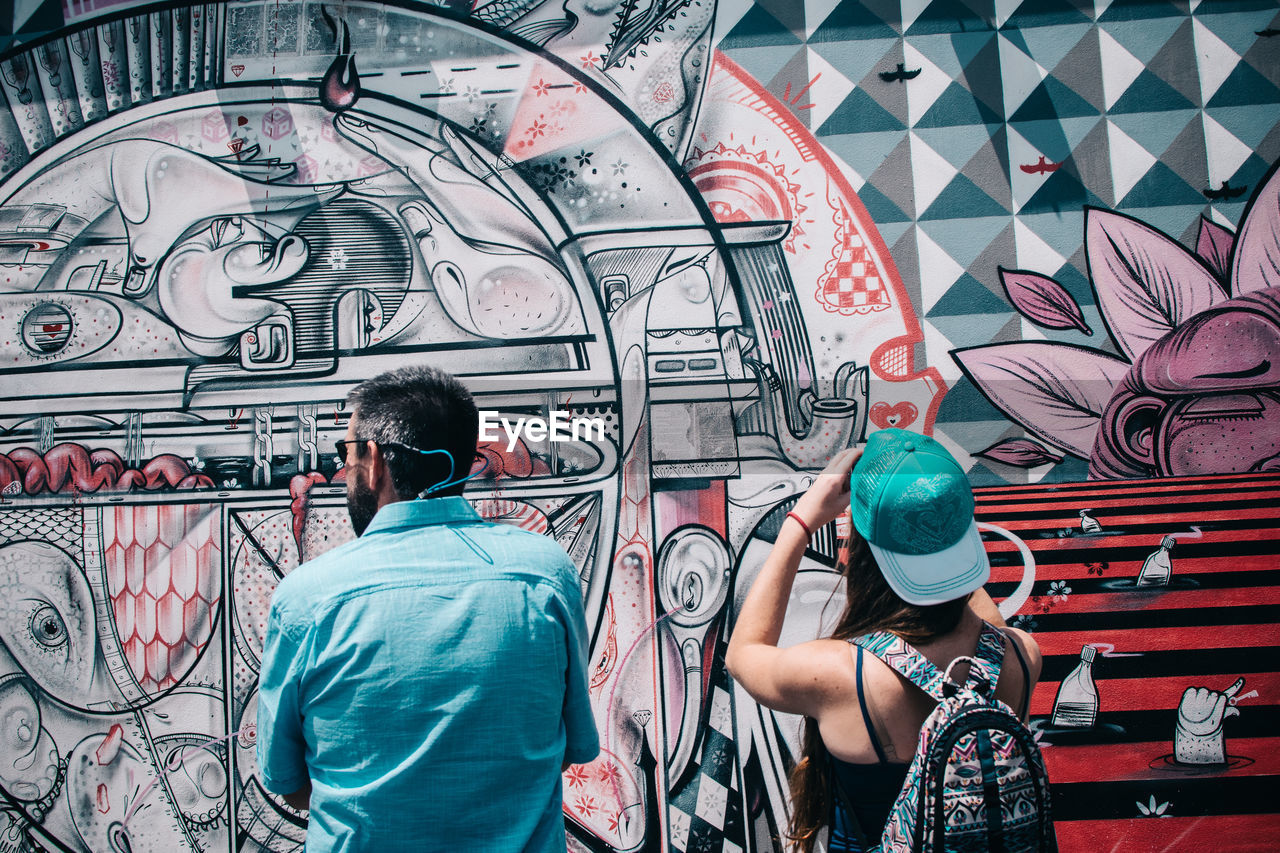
[867,521,991,606]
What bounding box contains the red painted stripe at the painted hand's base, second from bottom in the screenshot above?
[1041,729,1280,784]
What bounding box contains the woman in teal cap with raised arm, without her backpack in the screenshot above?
[726,429,1041,853]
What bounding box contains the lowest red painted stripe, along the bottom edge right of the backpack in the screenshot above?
[1053,804,1280,853]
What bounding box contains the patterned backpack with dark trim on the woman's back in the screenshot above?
[839,622,1057,853]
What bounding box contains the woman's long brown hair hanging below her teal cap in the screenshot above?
[787,532,969,853]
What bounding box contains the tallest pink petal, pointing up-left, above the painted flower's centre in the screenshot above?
[1084,207,1226,360]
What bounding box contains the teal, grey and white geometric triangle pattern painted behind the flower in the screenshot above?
[718,0,1280,484]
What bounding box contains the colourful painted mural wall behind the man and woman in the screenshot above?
[0,0,1280,853]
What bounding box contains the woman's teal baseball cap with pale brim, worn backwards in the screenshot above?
[850,429,991,606]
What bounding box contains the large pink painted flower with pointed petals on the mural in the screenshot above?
[952,164,1280,479]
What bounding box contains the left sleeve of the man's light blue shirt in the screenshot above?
[257,597,310,794]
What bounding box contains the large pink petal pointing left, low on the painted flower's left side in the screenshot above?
[951,341,1129,459]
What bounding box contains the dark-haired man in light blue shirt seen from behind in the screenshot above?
[257,368,599,853]
